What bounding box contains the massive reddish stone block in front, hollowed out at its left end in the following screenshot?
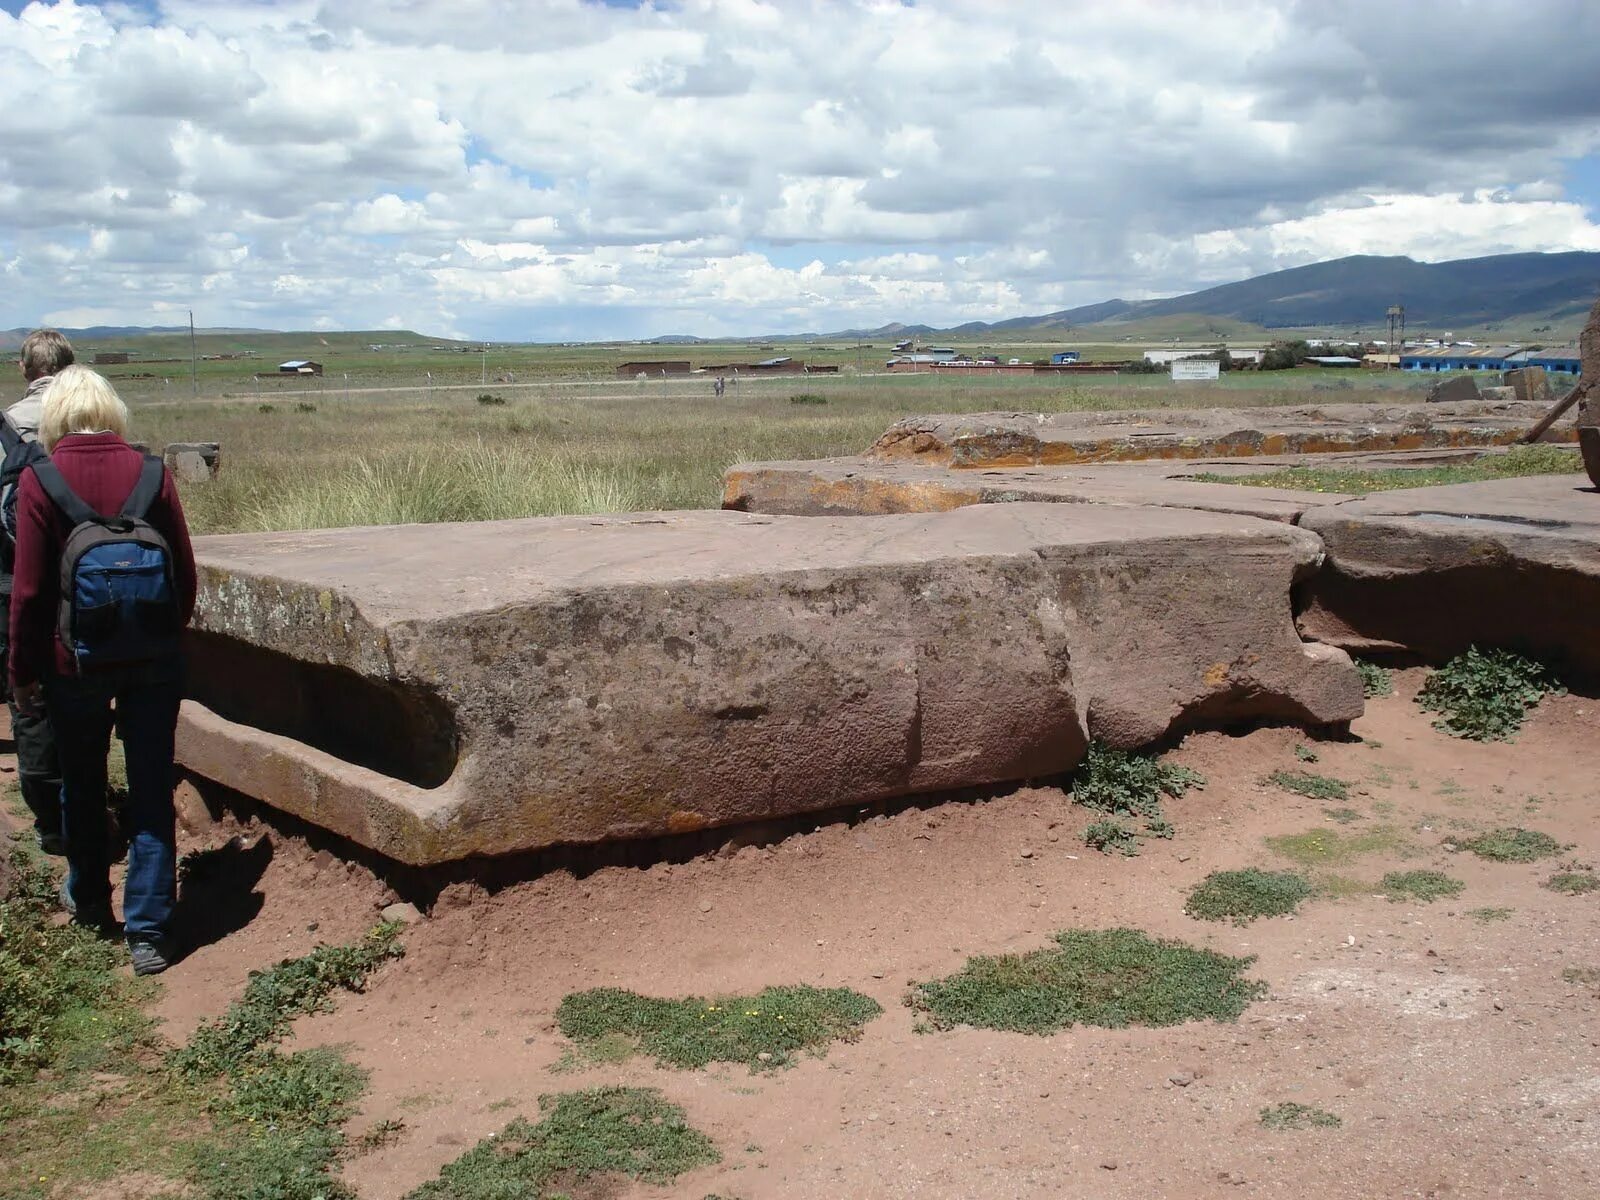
[178,504,1362,864]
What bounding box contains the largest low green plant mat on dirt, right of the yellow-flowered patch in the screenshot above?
[906,930,1267,1034]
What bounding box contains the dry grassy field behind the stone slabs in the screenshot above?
[128,371,1427,533]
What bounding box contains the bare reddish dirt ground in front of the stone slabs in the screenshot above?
[12,670,1600,1200]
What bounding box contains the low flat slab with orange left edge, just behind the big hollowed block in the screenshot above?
[723,458,1349,523]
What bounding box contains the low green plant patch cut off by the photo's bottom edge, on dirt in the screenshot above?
[406,1088,722,1200]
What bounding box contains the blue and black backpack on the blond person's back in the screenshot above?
[32,456,181,674]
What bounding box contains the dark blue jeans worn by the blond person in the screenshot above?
[45,661,182,939]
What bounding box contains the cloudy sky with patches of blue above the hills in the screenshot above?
[0,0,1600,341]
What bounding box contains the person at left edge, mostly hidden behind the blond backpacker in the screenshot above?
[0,330,75,854]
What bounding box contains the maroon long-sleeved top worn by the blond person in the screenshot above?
[11,434,195,688]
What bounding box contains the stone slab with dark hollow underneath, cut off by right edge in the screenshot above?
[1298,475,1600,678]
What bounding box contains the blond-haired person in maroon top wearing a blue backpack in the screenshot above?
[11,366,195,974]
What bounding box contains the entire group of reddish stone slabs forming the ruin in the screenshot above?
[179,315,1600,867]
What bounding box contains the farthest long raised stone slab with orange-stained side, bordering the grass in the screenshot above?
[866,402,1576,469]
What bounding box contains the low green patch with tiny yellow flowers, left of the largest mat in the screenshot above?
[555,984,883,1070]
